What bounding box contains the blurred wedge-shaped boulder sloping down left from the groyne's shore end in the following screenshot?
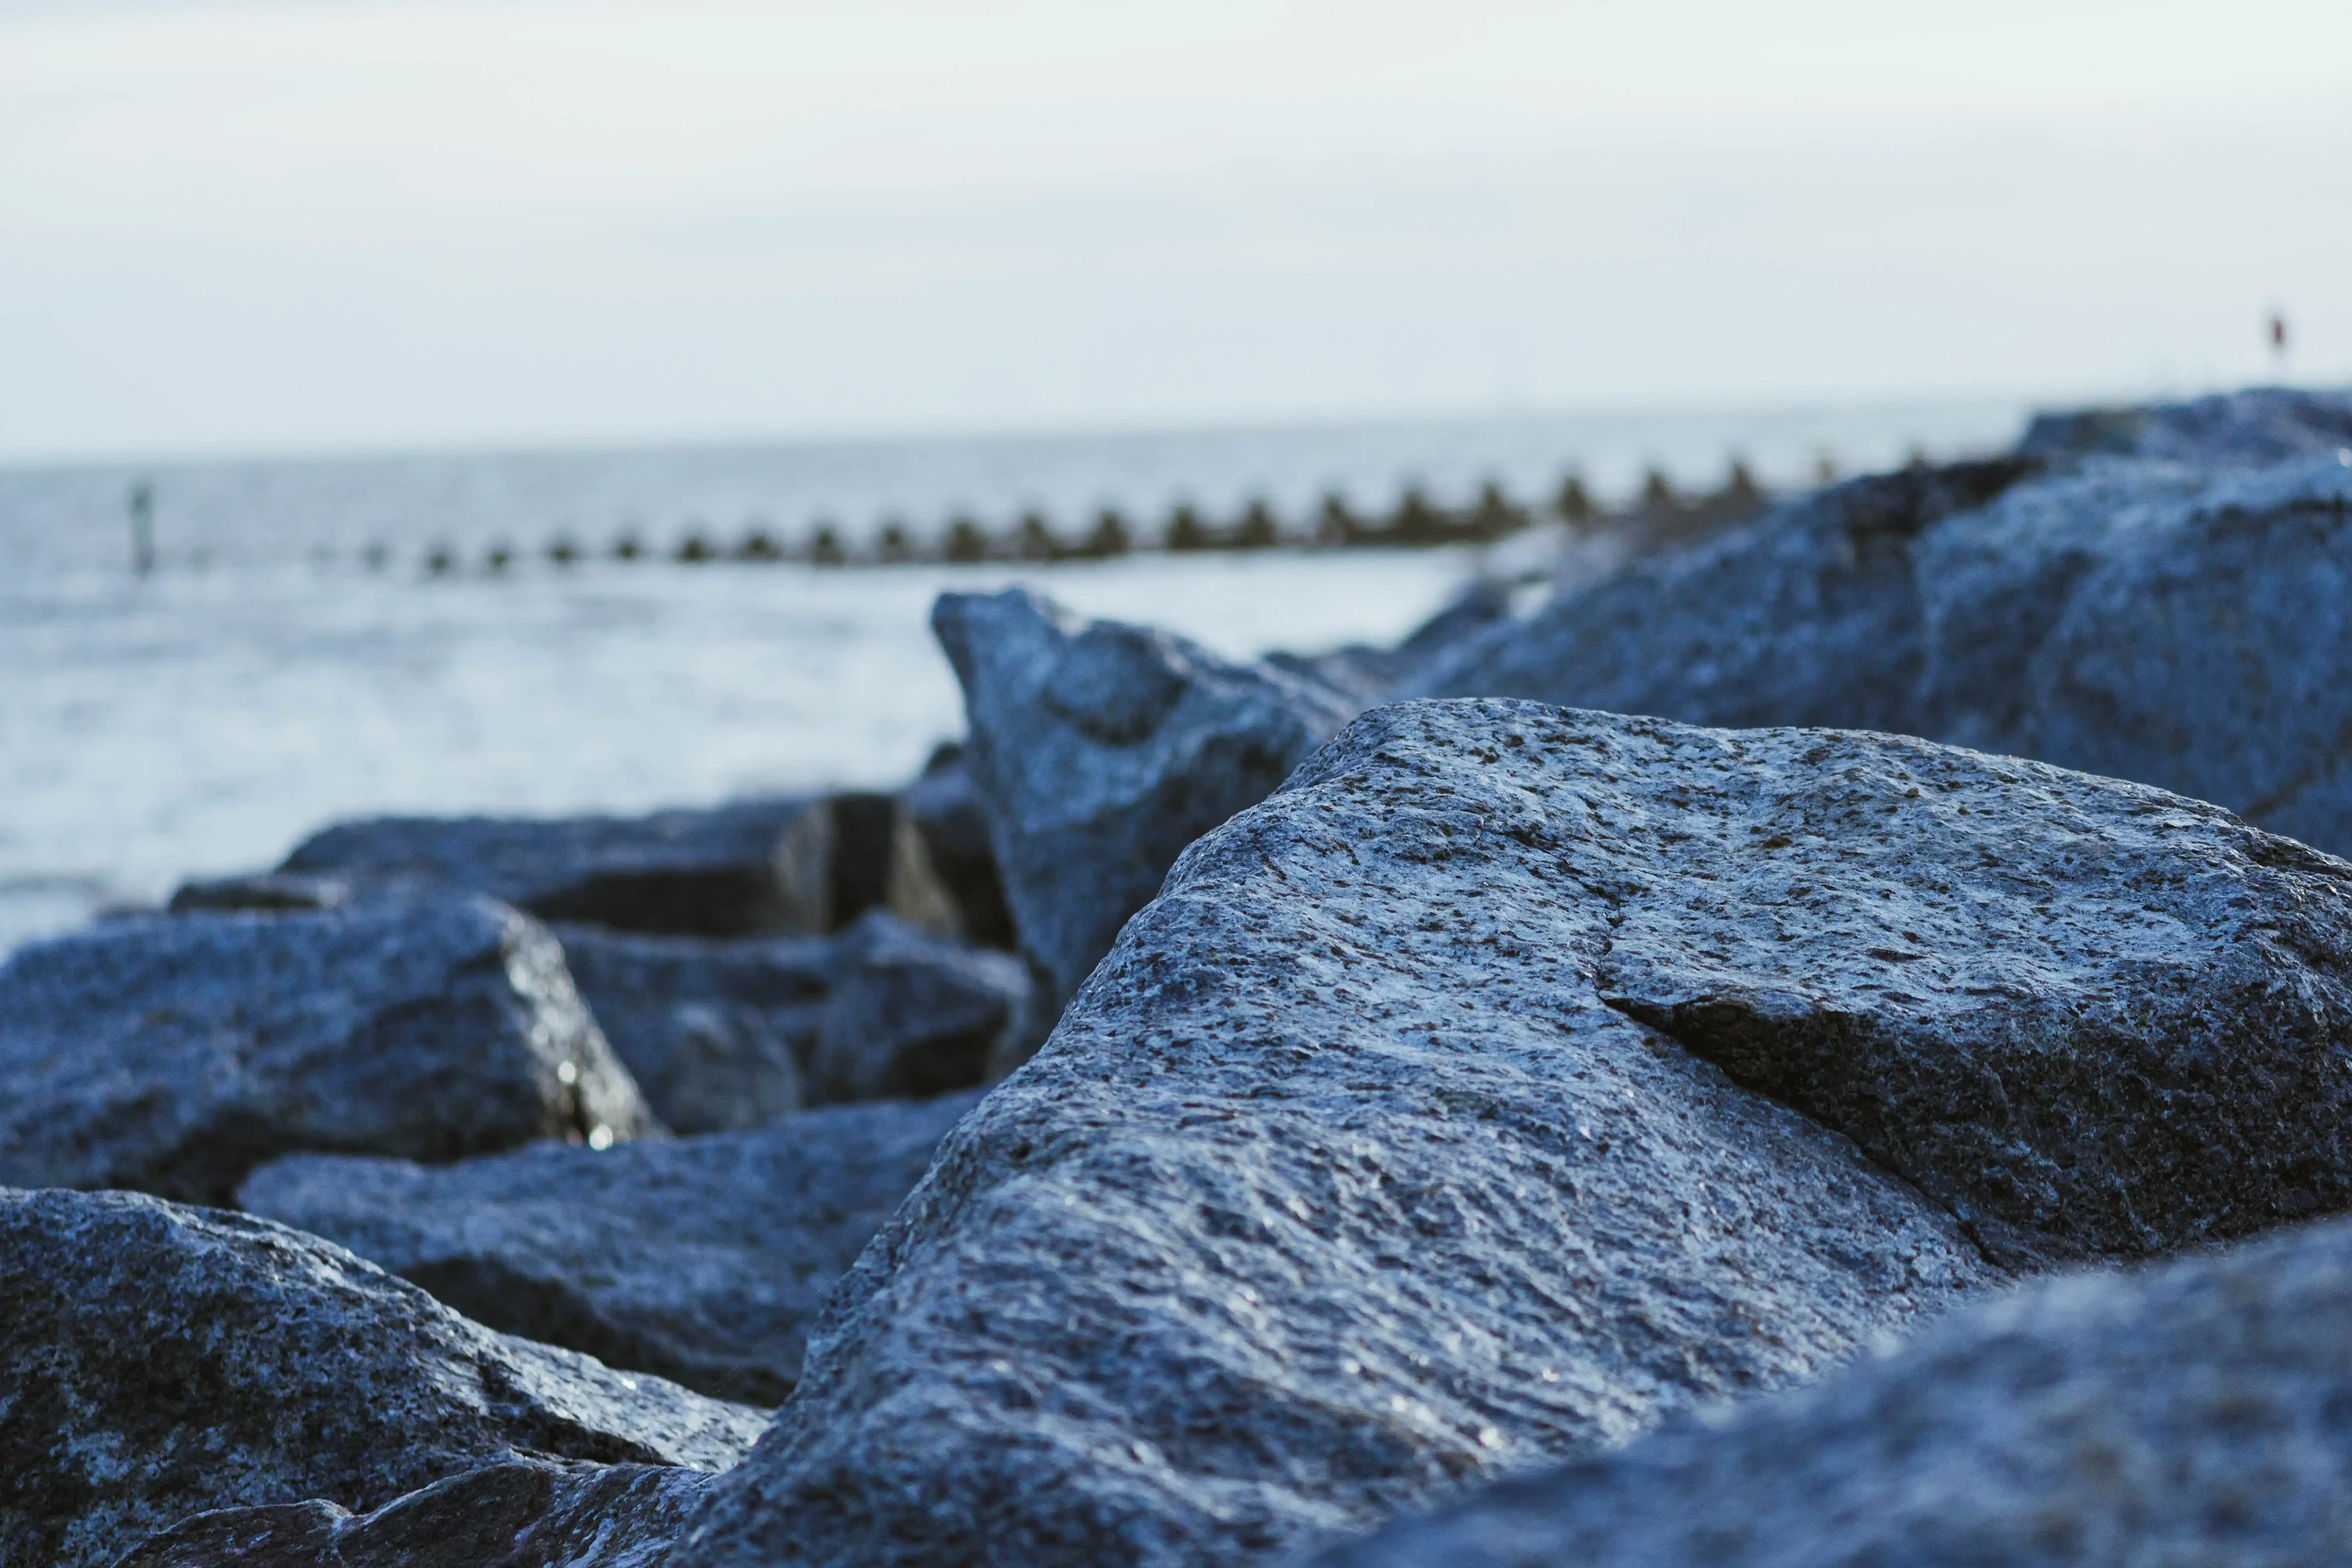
[1399,459,2032,731]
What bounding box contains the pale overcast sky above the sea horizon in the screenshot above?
[0,0,2352,461]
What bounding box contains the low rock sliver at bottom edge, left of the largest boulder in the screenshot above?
[120,1460,710,1568]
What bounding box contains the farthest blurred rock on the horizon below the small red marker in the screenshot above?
[2018,386,2352,466]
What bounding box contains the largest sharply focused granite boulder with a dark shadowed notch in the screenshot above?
[691,703,2352,1568]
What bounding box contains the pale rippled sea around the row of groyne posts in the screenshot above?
[0,402,2025,952]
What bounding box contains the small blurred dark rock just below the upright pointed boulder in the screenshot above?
[560,909,1030,1133]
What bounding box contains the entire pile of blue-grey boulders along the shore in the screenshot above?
[0,390,2352,1568]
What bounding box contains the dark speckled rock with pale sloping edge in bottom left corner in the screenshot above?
[0,1189,764,1568]
